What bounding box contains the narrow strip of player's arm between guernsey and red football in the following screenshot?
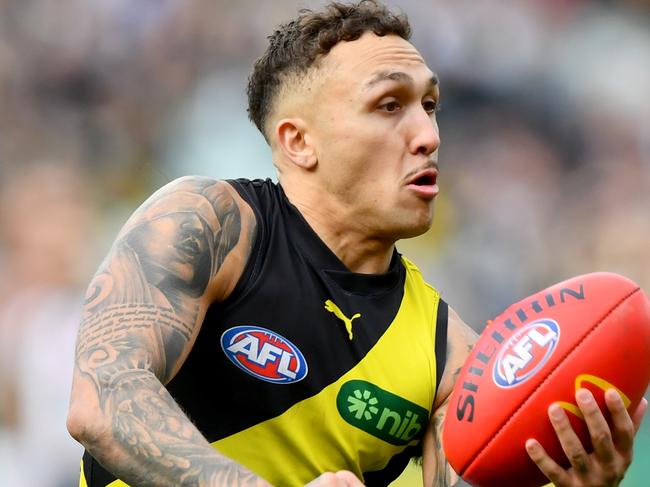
[422,308,477,487]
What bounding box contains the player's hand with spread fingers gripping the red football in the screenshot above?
[526,389,648,487]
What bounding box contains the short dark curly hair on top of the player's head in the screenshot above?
[246,0,411,142]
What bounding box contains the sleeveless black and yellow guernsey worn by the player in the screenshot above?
[80,180,447,487]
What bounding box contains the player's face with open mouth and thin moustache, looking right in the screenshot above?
[312,33,440,238]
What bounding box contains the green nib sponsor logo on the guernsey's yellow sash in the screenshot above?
[336,380,429,445]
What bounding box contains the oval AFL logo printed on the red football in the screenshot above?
[492,319,560,388]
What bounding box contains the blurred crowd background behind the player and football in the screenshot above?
[0,0,650,487]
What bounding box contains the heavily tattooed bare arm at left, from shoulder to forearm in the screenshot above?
[68,178,268,486]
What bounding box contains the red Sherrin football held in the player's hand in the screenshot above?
[443,273,650,487]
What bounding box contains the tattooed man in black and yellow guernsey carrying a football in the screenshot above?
[68,1,642,487]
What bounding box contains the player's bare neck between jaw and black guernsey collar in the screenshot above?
[284,188,395,274]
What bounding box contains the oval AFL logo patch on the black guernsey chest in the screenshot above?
[221,325,308,384]
